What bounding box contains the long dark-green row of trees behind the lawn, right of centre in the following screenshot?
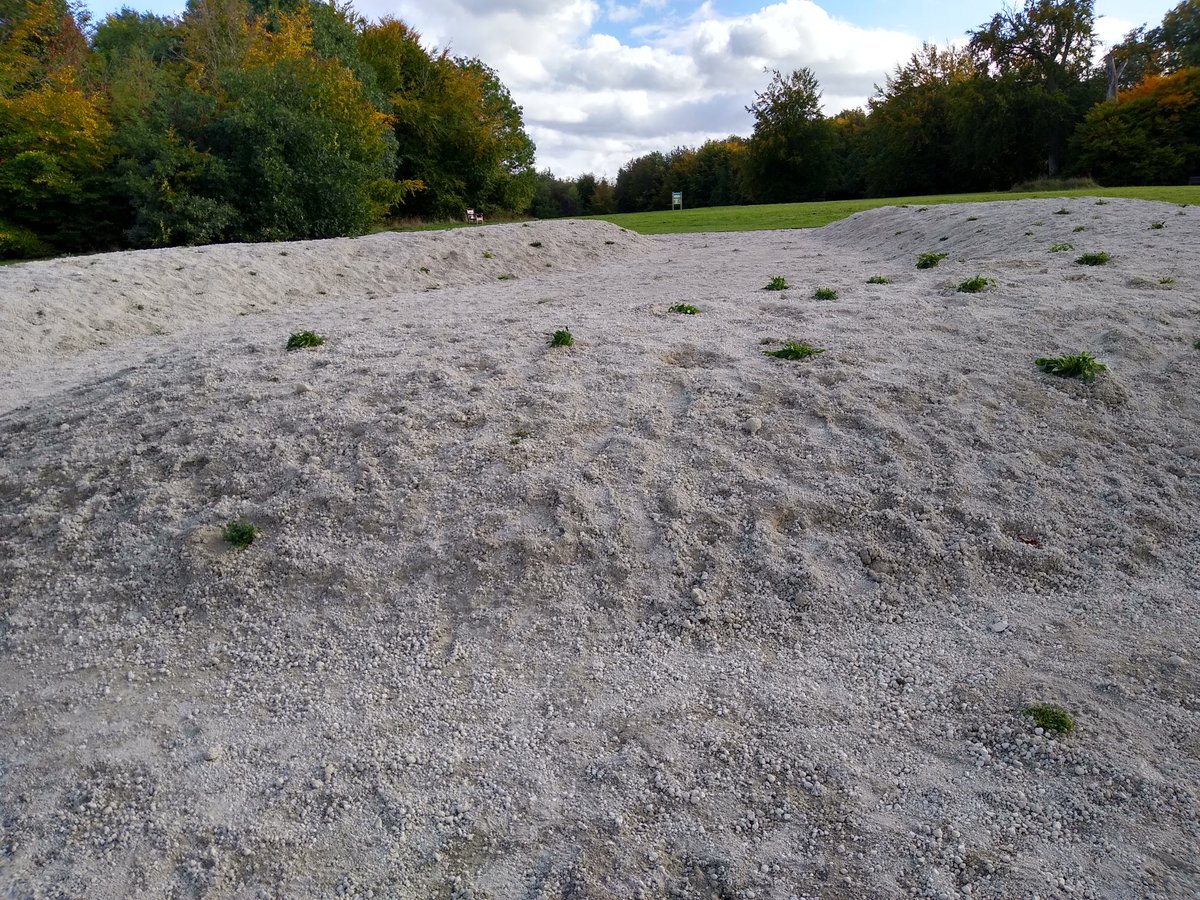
[534,0,1200,215]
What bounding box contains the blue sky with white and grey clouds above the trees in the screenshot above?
[88,0,1177,179]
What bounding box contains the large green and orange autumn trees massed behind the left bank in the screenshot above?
[0,0,536,258]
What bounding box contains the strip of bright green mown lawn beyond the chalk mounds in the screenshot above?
[590,185,1200,234]
